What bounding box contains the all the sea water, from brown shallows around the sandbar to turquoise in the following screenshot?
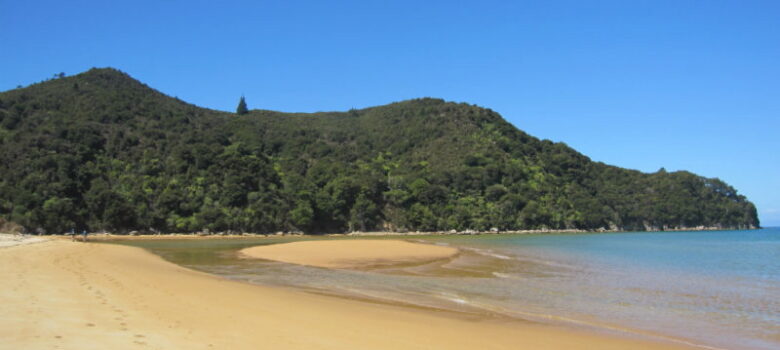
[123,228,780,350]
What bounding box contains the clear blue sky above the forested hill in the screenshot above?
[0,0,780,226]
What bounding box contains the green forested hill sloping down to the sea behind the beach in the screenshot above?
[0,69,759,233]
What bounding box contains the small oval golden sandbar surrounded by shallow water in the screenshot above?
[240,239,458,269]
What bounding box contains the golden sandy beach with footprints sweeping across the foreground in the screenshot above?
[0,240,696,349]
